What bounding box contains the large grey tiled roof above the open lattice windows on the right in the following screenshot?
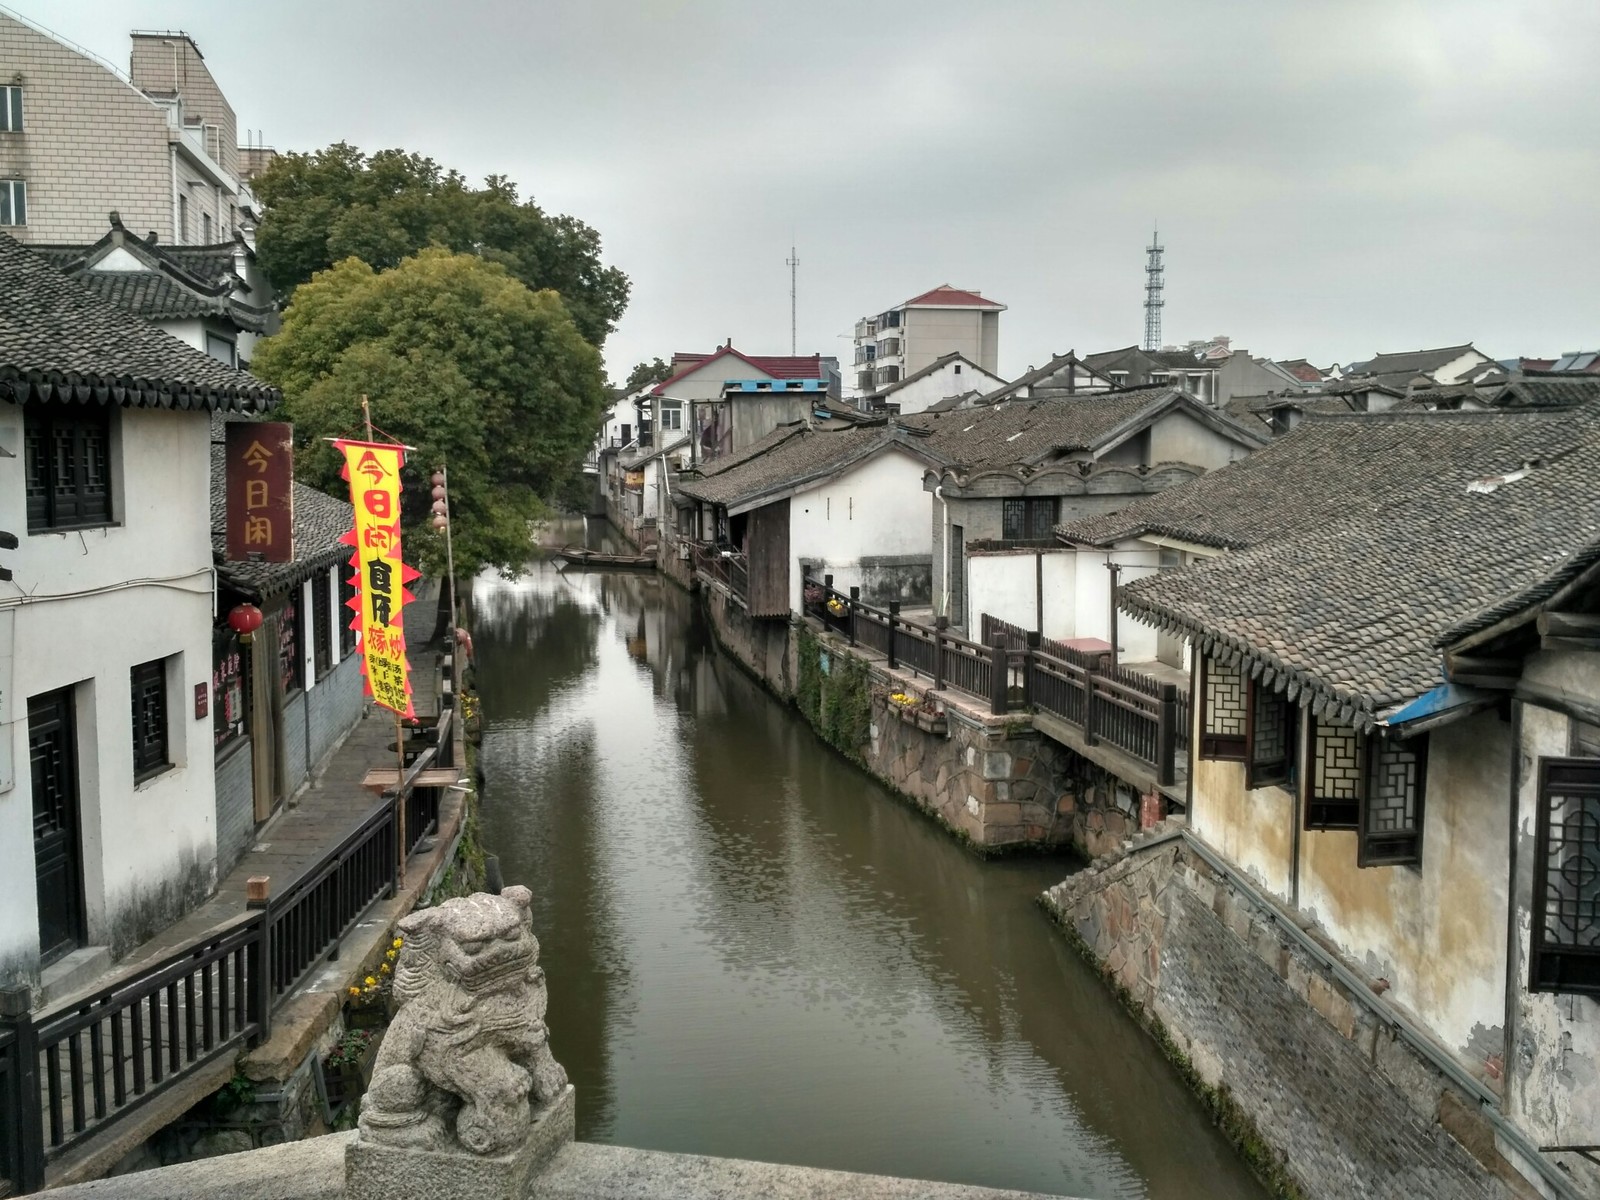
[1120,408,1600,728]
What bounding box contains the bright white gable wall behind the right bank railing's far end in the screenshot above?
[789,450,933,613]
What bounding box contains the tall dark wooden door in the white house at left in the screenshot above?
[27,688,85,966]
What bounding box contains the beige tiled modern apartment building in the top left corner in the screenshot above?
[0,10,254,245]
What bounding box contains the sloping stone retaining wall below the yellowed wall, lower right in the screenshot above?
[1045,827,1533,1200]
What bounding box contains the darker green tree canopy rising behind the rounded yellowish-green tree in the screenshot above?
[251,142,629,346]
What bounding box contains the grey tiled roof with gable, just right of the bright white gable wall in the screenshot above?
[901,387,1264,467]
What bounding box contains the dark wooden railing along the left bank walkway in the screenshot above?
[0,662,454,1197]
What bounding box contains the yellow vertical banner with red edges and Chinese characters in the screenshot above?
[334,442,418,717]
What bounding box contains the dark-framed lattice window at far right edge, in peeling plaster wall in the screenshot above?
[1528,758,1600,995]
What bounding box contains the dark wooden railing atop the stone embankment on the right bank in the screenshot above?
[805,576,1189,786]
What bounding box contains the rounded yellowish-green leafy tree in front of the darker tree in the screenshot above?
[251,246,606,574]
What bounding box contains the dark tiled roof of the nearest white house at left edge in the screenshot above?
[0,235,280,411]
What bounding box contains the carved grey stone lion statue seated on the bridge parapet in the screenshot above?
[360,886,566,1155]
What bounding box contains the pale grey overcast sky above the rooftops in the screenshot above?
[15,0,1600,378]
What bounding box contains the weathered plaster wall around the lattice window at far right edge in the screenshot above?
[1507,651,1600,1164]
